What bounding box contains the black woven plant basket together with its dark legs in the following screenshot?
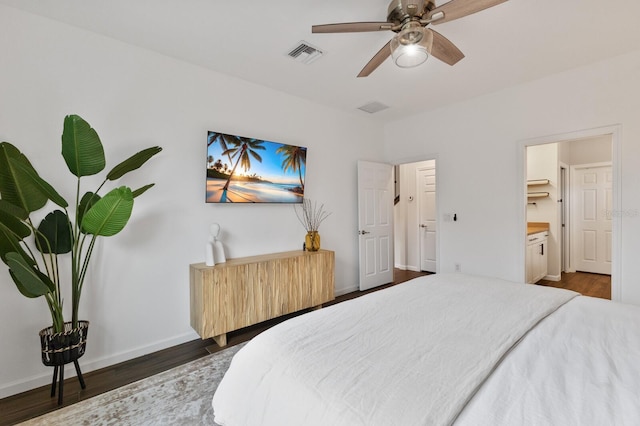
[40,321,89,405]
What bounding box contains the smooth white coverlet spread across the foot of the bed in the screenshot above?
[213,274,576,426]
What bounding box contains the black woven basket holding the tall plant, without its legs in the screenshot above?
[40,321,89,367]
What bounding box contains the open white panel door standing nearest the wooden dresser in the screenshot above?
[358,161,393,290]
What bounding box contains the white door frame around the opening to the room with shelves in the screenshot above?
[520,124,622,301]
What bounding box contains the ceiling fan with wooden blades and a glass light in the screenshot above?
[311,0,507,77]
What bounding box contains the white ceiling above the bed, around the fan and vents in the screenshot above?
[0,0,640,121]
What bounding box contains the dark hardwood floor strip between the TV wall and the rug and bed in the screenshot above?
[0,269,425,426]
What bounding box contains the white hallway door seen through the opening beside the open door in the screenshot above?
[417,167,437,273]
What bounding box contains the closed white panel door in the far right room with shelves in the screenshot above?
[572,166,613,275]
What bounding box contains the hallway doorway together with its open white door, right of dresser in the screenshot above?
[358,159,438,291]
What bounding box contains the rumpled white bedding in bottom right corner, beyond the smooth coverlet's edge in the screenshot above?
[456,296,640,426]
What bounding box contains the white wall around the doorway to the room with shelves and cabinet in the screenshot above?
[385,47,640,305]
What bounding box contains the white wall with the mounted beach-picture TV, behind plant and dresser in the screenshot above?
[0,6,383,397]
